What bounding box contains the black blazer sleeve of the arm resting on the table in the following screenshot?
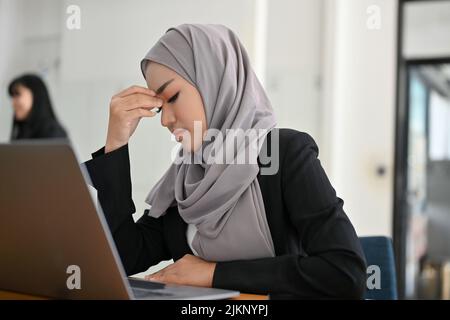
[213,132,366,299]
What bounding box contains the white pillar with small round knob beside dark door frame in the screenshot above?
[322,0,397,235]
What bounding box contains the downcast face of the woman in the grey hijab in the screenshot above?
[145,61,207,152]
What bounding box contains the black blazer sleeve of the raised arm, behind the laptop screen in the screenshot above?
[85,145,171,275]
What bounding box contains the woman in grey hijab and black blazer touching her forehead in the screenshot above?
[86,24,366,298]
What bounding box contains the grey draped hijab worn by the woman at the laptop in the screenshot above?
[141,24,276,261]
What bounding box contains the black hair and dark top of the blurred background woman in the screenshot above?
[8,74,67,140]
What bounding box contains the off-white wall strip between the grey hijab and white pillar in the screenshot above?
[266,0,323,146]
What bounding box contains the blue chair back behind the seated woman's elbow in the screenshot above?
[359,236,397,300]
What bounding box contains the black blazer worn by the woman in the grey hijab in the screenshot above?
[85,129,366,299]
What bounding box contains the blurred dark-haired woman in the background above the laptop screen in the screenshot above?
[8,74,67,140]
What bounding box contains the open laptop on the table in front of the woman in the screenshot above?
[0,140,239,300]
